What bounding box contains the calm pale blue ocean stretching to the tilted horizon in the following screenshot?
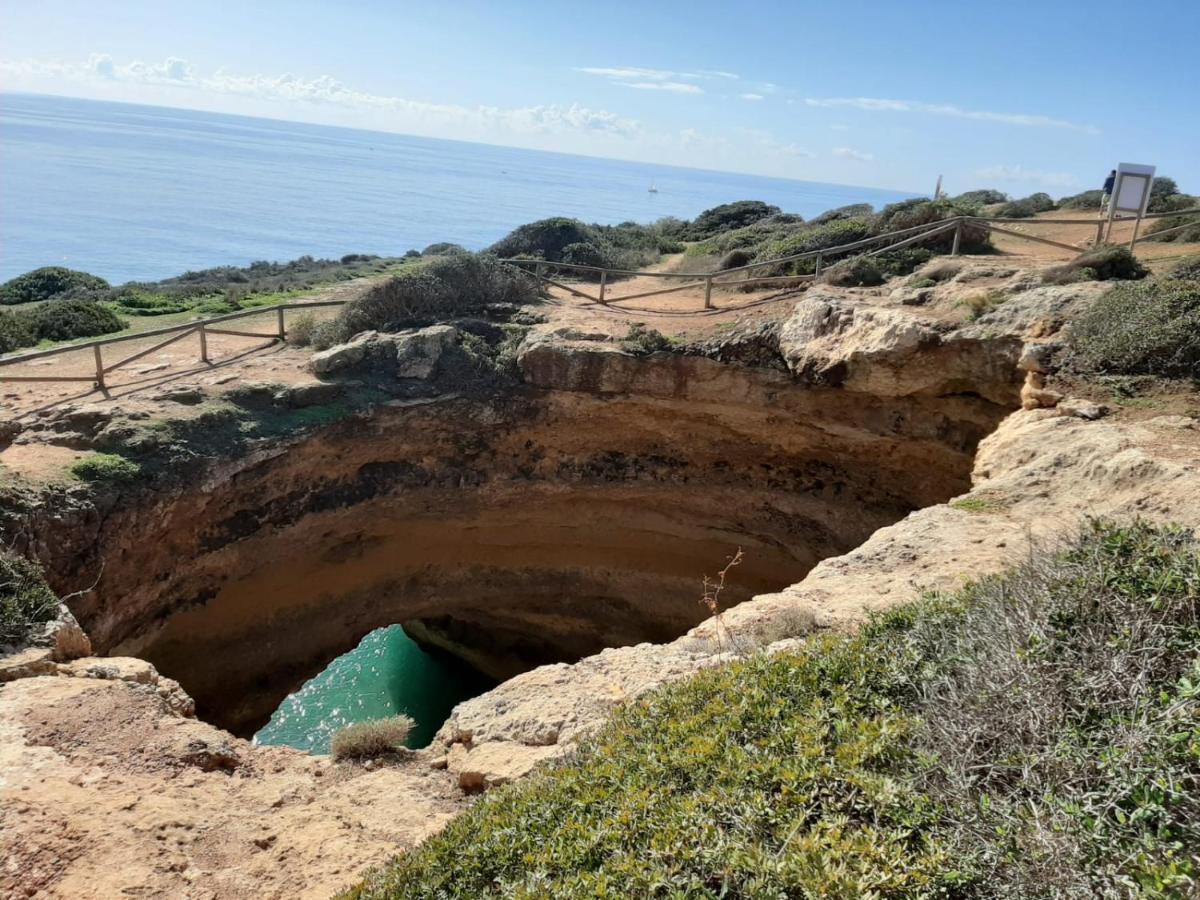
[0,94,912,283]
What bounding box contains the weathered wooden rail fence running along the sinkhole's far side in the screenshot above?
[0,208,1200,389]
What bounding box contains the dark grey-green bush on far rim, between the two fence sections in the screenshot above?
[326,253,536,346]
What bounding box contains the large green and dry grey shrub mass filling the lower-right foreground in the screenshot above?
[347,524,1200,900]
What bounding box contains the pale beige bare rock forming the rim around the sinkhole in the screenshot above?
[0,250,1200,898]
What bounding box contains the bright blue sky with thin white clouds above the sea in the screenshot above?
[0,0,1200,197]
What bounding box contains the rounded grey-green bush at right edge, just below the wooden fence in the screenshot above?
[1068,280,1200,378]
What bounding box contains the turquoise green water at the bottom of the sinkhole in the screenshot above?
[254,625,494,754]
